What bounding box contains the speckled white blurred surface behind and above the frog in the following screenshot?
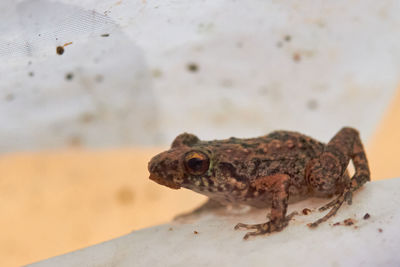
[0,0,400,152]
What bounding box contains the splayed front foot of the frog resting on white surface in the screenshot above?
[235,212,298,240]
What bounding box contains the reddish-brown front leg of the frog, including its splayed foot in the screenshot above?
[235,174,296,239]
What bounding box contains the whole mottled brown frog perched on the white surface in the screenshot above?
[148,127,370,239]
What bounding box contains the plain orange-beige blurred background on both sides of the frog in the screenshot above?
[0,87,400,266]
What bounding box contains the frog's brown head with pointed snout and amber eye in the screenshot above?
[148,133,211,189]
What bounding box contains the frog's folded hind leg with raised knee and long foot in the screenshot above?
[306,128,370,227]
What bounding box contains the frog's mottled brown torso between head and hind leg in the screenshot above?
[182,131,330,208]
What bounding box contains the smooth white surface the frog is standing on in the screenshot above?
[30,178,400,267]
